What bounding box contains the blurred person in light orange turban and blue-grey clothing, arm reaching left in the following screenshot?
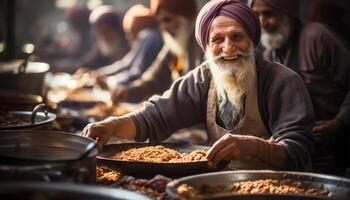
[90,4,163,89]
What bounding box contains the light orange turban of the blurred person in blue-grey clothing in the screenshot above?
[123,4,157,35]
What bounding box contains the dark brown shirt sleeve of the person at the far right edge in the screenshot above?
[300,22,350,124]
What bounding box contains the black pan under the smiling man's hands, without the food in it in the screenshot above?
[97,143,228,178]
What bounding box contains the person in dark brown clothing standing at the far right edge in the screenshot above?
[299,0,350,175]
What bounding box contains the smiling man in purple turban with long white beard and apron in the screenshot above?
[82,0,314,170]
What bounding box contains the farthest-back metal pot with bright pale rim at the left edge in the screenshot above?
[0,60,50,96]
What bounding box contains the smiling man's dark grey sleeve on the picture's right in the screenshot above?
[259,61,315,170]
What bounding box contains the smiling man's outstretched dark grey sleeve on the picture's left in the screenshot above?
[131,67,210,142]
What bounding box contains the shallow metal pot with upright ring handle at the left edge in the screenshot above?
[0,104,56,130]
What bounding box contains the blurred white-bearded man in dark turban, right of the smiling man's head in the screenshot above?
[248,0,302,72]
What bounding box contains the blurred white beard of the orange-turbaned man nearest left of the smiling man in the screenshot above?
[162,17,191,56]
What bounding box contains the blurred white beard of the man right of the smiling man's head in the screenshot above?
[260,16,291,50]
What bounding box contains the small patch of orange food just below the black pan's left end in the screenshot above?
[96,167,123,184]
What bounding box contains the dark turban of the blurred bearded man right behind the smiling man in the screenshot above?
[248,0,299,19]
